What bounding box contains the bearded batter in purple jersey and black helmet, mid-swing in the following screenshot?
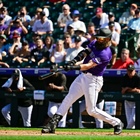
[41,28,123,135]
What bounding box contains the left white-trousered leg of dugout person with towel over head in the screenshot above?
[1,104,11,125]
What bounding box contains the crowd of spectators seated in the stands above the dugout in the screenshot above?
[0,0,140,68]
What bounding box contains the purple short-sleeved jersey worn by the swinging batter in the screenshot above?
[83,42,112,76]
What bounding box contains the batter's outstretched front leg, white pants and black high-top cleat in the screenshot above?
[41,75,83,133]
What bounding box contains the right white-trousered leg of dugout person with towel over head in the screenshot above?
[18,105,33,127]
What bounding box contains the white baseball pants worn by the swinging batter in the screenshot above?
[57,73,120,126]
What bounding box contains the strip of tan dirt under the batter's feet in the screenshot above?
[0,130,140,136]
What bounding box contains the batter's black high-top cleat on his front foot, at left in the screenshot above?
[41,114,62,133]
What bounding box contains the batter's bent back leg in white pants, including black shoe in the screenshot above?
[84,76,122,134]
